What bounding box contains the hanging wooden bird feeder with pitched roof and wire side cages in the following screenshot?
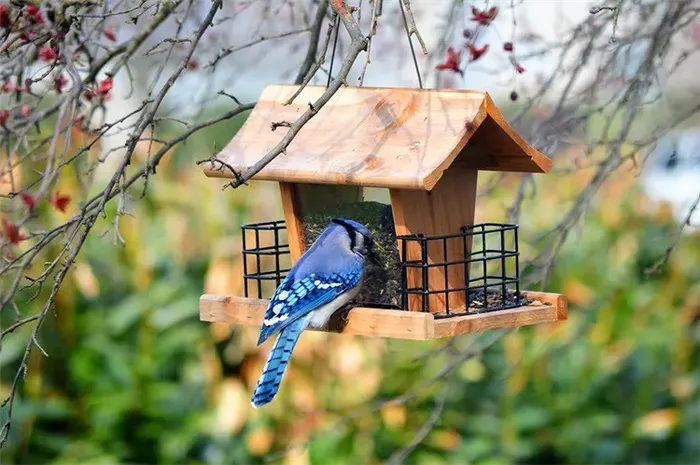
[200,85,567,339]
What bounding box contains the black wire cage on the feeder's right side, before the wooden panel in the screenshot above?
[397,223,524,318]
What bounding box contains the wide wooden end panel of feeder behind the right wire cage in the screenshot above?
[390,168,477,313]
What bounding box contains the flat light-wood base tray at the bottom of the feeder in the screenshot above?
[199,291,568,340]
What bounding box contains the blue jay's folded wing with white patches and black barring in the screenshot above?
[258,269,362,345]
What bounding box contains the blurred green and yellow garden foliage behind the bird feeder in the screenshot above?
[0,1,700,465]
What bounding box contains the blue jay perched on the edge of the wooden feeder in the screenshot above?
[251,218,379,408]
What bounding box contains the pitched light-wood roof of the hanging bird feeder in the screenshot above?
[205,85,552,190]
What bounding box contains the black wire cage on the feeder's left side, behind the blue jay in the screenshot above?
[241,220,291,299]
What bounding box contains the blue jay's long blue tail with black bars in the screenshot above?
[251,316,309,408]
